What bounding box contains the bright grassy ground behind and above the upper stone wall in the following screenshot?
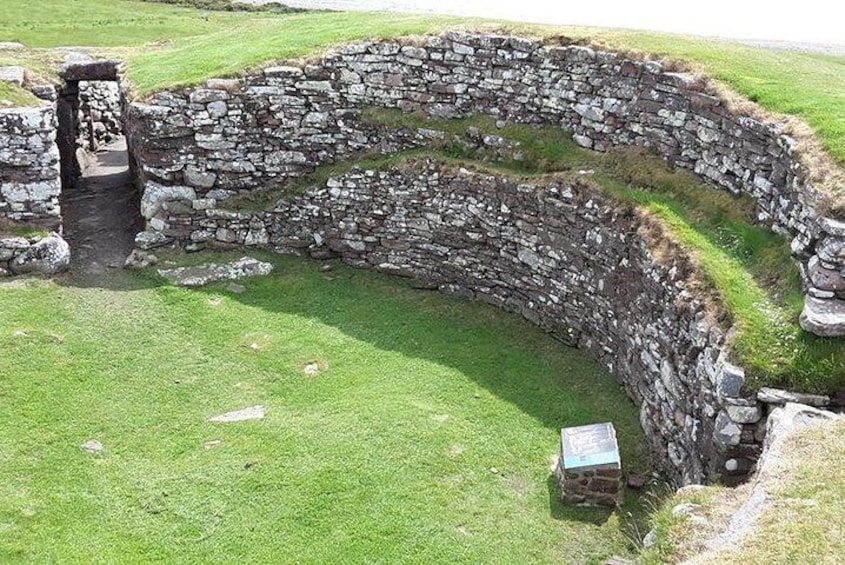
[0,0,845,164]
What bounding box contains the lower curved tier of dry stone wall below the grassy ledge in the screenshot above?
[138,161,762,483]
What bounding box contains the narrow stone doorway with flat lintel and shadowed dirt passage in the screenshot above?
[56,61,143,275]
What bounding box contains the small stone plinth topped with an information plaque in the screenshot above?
[554,422,623,507]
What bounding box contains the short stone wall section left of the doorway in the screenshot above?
[0,103,61,229]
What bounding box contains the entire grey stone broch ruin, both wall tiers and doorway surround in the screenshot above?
[0,32,845,483]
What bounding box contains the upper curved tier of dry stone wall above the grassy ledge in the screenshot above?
[128,33,845,335]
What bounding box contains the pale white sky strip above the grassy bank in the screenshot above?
[259,0,845,45]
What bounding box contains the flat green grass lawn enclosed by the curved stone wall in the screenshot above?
[0,256,647,563]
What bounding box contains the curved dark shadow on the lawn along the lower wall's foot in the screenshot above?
[59,252,649,525]
